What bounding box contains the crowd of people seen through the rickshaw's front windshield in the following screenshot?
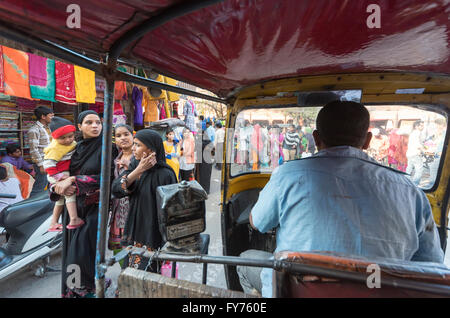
[232,116,446,186]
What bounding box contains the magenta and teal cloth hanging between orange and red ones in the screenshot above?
[28,53,55,102]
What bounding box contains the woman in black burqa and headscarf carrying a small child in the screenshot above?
[54,110,117,297]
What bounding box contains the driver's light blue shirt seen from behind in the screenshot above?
[251,146,444,297]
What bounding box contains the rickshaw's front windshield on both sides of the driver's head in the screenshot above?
[227,105,447,190]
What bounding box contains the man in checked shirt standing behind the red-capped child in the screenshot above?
[28,106,54,197]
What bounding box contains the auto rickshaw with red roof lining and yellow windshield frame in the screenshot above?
[0,0,450,297]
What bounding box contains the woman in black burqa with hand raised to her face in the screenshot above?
[112,129,177,272]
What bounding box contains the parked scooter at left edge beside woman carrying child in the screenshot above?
[0,192,62,281]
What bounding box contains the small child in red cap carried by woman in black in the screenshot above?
[44,117,84,232]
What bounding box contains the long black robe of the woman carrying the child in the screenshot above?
[62,135,117,297]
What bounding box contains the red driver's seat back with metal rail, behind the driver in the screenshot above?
[273,251,450,298]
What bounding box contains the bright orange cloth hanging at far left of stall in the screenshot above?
[3,46,31,99]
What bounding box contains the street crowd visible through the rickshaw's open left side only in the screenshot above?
[0,106,225,297]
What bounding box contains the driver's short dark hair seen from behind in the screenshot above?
[316,101,370,148]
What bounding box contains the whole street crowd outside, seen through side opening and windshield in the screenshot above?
[0,106,445,297]
